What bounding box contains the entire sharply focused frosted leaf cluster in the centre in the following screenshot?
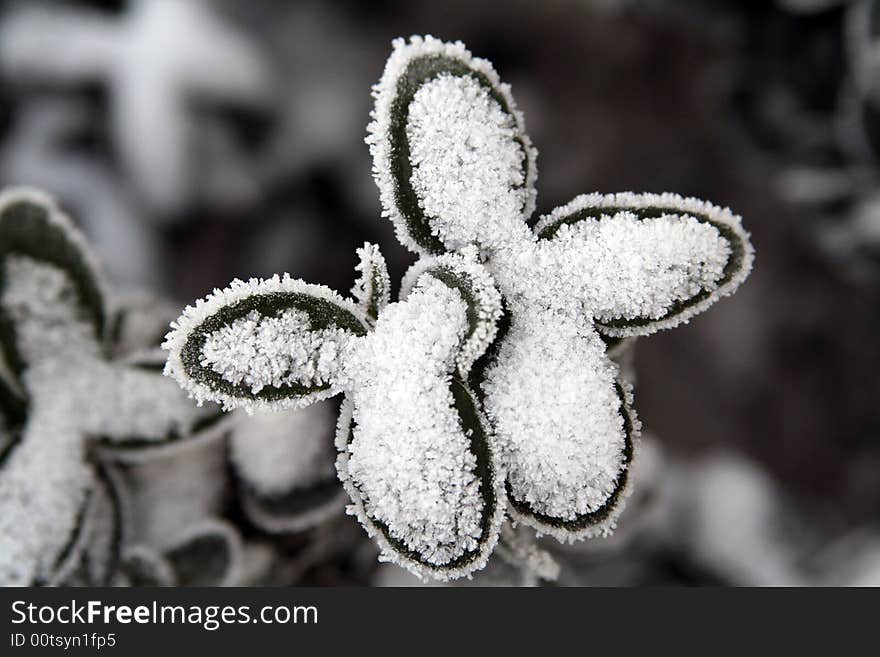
[163,37,753,580]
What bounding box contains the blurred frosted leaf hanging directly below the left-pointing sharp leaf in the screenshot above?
[229,401,345,533]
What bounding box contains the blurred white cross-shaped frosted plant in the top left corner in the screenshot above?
[0,0,271,212]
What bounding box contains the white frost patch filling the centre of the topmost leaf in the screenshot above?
[407,74,528,250]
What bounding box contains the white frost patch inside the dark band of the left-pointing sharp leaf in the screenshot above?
[201,308,348,394]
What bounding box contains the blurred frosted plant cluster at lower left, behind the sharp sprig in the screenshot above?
[0,188,344,585]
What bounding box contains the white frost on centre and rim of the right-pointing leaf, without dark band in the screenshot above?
[528,192,754,337]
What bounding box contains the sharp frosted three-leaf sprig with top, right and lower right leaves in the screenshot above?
[367,36,753,541]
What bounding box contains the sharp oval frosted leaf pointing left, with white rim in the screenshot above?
[162,274,367,410]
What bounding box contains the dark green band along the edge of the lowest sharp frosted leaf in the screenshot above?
[347,377,497,571]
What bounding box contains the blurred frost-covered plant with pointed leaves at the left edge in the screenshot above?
[0,188,210,584]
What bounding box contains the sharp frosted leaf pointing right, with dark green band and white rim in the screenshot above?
[535,193,754,336]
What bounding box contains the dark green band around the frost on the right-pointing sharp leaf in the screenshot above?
[538,206,746,330]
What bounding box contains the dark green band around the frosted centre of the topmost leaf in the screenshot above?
[389,55,529,255]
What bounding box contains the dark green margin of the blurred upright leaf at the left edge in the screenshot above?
[0,201,104,373]
